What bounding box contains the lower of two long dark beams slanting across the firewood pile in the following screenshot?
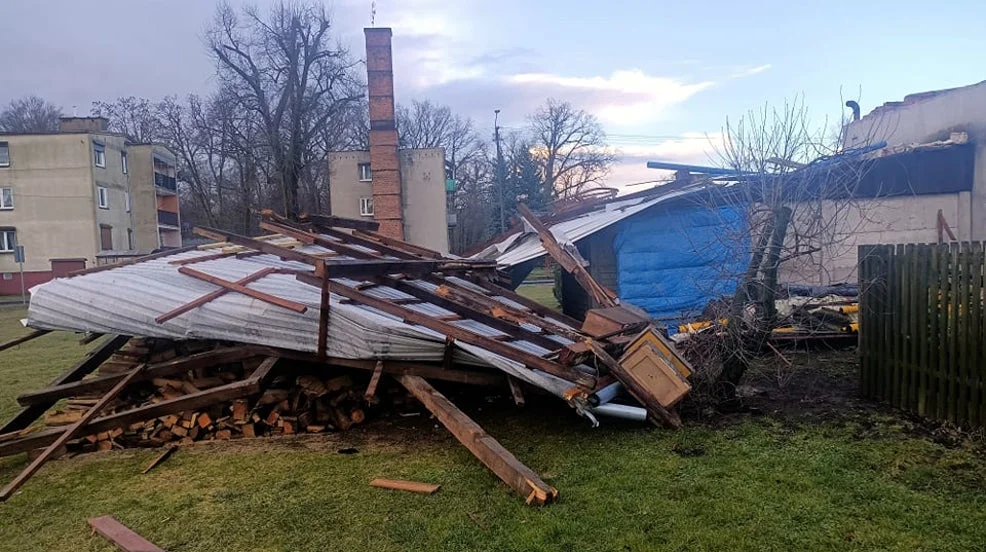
[0,378,260,456]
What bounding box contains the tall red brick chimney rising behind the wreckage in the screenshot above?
[363,28,404,240]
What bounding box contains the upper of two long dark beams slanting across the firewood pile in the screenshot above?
[17,346,267,406]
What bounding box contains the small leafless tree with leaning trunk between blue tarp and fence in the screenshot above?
[692,98,868,397]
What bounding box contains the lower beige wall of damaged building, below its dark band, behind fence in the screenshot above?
[779,192,971,285]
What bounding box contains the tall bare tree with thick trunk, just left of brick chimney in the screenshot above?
[207,1,363,218]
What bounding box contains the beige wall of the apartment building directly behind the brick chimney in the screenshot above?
[328,148,448,252]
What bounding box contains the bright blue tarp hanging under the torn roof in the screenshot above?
[613,204,750,328]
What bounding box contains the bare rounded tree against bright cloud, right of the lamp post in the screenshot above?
[528,99,614,198]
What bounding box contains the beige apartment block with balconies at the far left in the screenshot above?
[0,117,181,295]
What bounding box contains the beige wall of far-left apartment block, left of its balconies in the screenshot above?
[0,134,100,273]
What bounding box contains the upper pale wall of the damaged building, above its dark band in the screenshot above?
[845,82,986,239]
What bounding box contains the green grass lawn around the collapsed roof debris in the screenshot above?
[0,304,986,552]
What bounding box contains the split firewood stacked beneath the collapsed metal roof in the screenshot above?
[45,340,370,450]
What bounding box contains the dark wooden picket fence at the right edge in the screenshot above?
[859,242,986,426]
